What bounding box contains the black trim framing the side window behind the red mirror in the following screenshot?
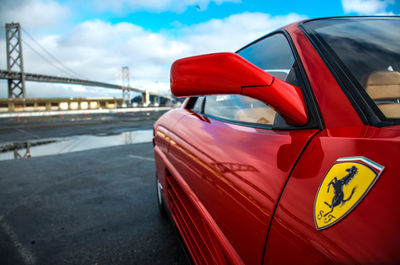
[187,29,325,130]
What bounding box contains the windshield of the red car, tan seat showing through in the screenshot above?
[304,17,400,119]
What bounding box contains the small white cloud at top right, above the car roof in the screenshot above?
[342,0,395,15]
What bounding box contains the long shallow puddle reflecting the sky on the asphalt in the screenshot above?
[0,130,153,160]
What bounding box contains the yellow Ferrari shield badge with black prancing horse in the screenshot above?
[314,157,384,230]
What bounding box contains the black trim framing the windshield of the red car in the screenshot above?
[298,16,400,127]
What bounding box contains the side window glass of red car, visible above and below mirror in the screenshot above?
[204,33,302,125]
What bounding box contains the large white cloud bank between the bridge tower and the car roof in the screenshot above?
[0,12,305,97]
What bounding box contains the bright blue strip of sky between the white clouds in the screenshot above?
[71,0,344,31]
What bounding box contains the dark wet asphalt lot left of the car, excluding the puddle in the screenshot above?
[0,112,188,265]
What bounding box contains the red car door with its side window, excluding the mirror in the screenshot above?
[167,32,319,264]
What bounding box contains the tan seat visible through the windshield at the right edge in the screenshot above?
[365,71,400,118]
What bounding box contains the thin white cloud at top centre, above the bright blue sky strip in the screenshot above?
[95,0,241,13]
